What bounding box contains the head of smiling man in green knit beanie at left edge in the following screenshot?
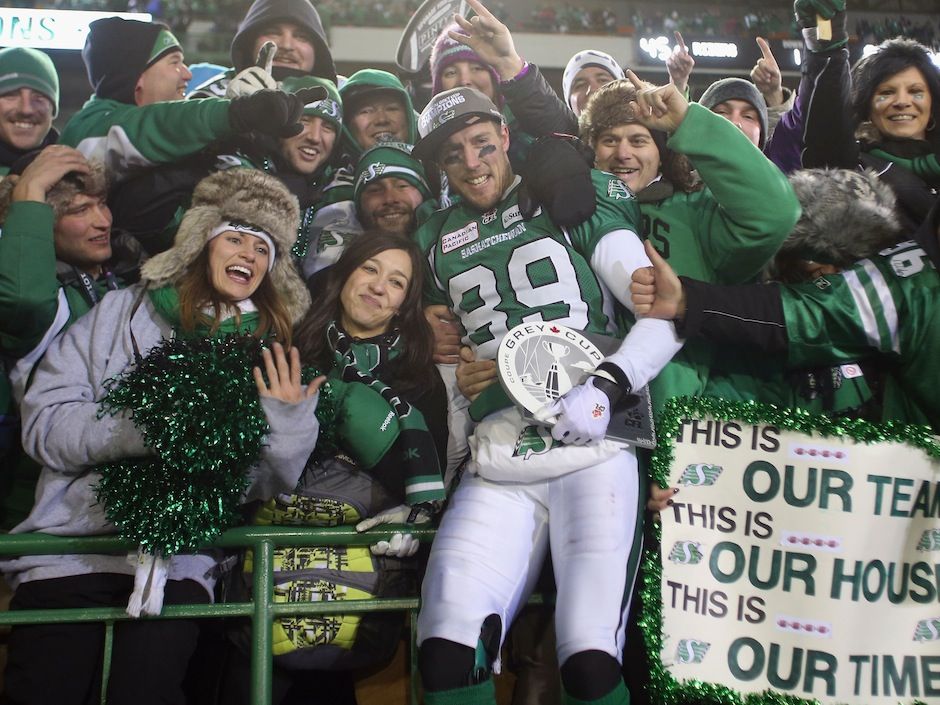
[0,47,59,176]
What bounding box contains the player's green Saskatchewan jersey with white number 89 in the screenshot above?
[415,171,640,359]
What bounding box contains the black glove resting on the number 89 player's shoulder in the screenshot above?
[519,135,597,228]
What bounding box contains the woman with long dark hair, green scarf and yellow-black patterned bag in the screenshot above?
[222,230,447,705]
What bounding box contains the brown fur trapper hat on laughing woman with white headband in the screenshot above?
[140,169,310,323]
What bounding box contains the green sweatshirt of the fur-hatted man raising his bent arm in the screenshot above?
[637,103,800,410]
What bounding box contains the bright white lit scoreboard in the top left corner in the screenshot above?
[0,7,152,49]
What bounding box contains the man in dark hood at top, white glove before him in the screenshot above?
[189,0,336,98]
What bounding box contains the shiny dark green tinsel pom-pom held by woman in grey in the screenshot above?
[95,333,335,556]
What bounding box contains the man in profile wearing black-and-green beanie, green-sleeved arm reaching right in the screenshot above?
[61,17,326,183]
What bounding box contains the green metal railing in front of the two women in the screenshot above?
[0,525,435,705]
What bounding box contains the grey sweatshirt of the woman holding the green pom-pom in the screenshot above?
[0,285,319,597]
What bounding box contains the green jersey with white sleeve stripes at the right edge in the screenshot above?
[780,241,940,431]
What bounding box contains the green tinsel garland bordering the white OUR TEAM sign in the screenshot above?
[639,397,940,705]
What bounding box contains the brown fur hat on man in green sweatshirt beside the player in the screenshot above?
[578,79,696,193]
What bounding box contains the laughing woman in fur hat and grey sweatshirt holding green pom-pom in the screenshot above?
[0,169,323,705]
